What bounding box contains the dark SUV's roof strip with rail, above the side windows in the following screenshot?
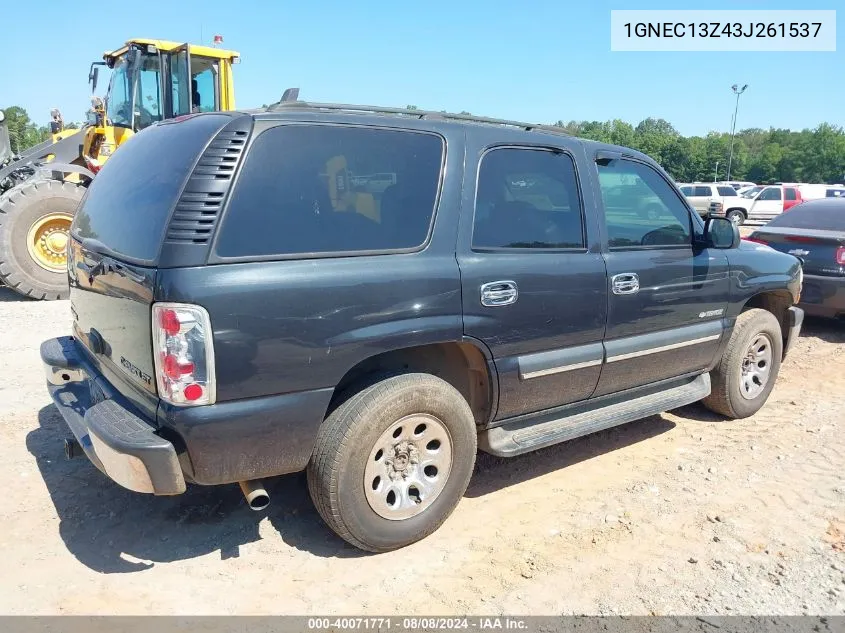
[243,101,656,164]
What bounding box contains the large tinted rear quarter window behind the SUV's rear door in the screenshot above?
[216,125,444,257]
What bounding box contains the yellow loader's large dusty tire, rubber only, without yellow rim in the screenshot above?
[0,179,85,300]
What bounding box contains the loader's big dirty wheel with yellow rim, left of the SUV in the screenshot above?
[0,179,85,300]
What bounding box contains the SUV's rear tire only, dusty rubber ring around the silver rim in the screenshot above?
[307,373,477,552]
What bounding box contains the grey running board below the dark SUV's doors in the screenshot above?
[478,374,710,457]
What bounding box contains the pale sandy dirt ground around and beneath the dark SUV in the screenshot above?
[0,289,845,615]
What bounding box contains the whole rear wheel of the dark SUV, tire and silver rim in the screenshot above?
[308,374,476,552]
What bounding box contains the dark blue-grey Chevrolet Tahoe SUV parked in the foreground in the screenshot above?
[41,102,803,551]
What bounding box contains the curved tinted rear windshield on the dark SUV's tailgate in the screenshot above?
[71,114,230,264]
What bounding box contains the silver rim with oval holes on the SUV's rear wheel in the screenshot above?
[363,414,452,521]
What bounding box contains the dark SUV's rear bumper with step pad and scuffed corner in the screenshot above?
[41,336,185,495]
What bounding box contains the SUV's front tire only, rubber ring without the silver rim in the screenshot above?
[702,308,783,419]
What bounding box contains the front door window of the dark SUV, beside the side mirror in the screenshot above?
[598,160,690,248]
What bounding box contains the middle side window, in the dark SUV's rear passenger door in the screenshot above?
[472,148,584,248]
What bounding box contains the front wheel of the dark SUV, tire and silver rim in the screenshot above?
[703,308,783,418]
